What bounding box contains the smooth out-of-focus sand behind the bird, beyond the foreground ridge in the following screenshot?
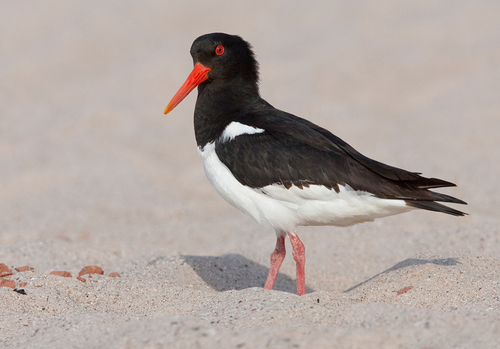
[0,0,500,288]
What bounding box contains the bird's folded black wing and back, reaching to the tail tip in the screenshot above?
[216,105,465,215]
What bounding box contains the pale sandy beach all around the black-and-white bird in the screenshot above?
[0,0,500,348]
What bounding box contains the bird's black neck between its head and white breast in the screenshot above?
[194,80,260,147]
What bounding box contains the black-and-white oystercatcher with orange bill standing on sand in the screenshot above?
[164,33,466,296]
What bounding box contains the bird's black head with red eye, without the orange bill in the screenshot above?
[191,33,258,85]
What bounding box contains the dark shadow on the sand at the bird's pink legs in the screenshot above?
[181,254,314,293]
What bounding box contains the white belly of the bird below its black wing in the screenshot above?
[198,143,413,232]
